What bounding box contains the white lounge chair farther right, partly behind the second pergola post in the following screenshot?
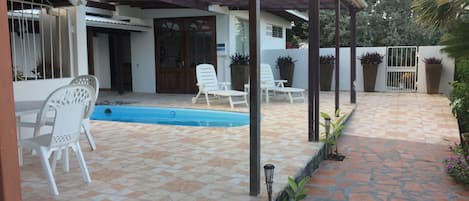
[261,64,305,104]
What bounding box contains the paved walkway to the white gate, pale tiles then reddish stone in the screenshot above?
[306,94,469,201]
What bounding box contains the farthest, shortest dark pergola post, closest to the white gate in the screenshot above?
[350,8,357,104]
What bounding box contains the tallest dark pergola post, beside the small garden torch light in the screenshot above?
[249,0,261,196]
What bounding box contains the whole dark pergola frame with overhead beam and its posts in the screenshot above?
[0,0,367,200]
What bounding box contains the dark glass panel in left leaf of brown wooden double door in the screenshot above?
[158,22,184,68]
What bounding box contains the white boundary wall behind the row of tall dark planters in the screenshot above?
[261,46,455,95]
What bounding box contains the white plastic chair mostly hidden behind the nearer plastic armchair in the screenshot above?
[70,75,99,150]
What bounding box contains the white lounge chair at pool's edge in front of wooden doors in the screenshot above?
[192,64,248,108]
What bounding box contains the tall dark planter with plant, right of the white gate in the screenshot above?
[423,57,442,94]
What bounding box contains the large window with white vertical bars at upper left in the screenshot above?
[8,1,72,81]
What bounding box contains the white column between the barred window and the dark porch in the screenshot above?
[70,5,88,76]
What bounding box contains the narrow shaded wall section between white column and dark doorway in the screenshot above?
[93,33,111,89]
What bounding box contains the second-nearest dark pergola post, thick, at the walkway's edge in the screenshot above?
[308,0,319,142]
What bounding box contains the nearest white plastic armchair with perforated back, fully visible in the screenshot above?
[20,85,94,195]
